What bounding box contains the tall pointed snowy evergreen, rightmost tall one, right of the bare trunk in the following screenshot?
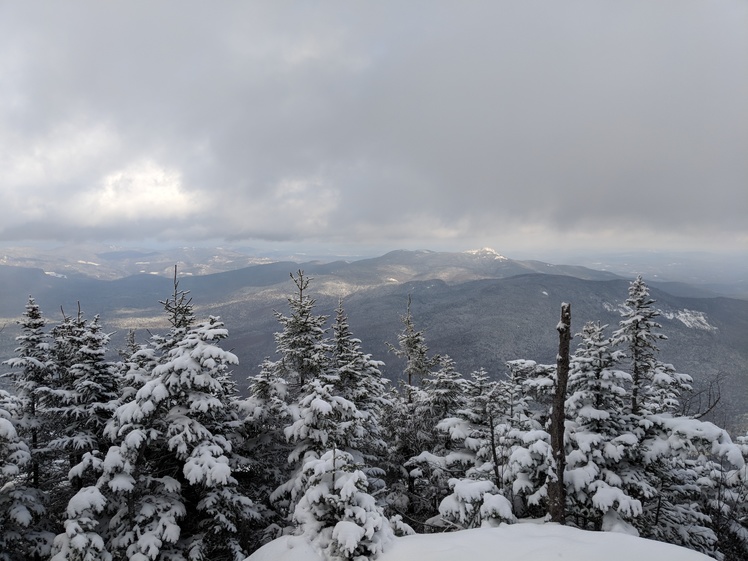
[614,276,742,556]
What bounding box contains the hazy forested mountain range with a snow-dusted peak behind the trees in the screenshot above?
[0,248,748,431]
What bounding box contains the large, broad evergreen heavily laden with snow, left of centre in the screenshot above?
[98,282,256,560]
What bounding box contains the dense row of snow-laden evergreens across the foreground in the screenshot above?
[0,271,748,561]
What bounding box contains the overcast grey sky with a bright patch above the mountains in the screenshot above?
[0,0,748,253]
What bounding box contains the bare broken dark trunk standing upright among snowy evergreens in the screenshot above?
[548,302,571,524]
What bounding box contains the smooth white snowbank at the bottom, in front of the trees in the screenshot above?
[247,524,713,561]
